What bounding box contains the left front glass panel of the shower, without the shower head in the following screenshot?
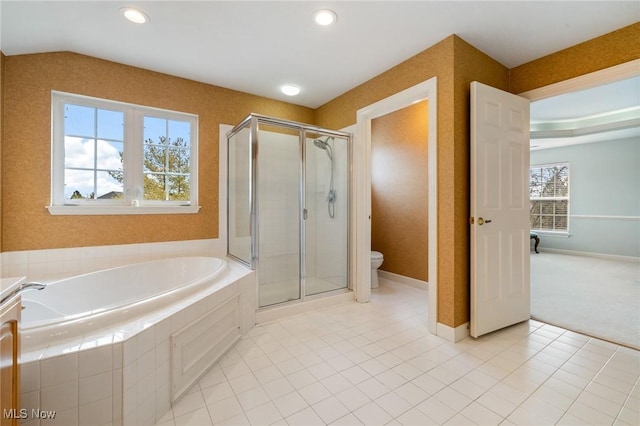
[257,123,301,307]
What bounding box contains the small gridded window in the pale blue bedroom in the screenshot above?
[529,163,569,232]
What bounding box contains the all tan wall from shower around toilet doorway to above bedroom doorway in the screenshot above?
[316,24,640,327]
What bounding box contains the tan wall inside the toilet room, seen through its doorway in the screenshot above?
[371,101,429,281]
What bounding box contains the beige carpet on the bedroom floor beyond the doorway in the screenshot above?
[531,252,640,349]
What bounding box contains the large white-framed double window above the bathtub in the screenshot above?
[49,92,198,214]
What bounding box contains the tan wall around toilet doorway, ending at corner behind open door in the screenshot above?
[316,35,509,327]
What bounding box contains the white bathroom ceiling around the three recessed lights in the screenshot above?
[0,0,640,108]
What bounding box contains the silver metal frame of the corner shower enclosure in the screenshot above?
[227,113,353,309]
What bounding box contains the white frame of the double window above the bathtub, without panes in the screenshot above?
[47,91,200,215]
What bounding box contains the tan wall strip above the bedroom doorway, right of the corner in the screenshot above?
[509,22,640,93]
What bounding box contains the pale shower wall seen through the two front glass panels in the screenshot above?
[258,132,349,284]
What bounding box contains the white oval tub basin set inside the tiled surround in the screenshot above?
[21,257,227,352]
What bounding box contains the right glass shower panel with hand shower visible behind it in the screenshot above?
[304,132,349,296]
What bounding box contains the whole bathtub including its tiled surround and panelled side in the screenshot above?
[20,257,256,426]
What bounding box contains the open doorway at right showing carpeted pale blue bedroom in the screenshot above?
[522,61,640,348]
